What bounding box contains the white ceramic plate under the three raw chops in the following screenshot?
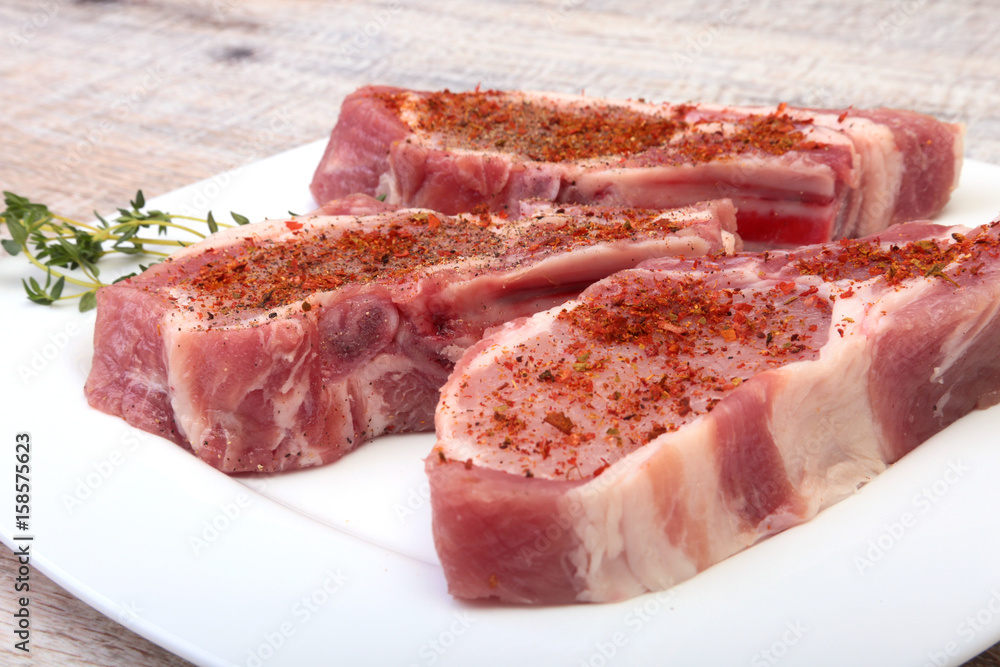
[0,142,1000,667]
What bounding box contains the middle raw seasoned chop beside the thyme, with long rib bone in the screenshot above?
[86,195,739,473]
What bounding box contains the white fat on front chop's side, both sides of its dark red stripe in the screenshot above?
[566,268,940,601]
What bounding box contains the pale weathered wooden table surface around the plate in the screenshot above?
[0,0,1000,666]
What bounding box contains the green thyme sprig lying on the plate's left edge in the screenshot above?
[0,190,249,312]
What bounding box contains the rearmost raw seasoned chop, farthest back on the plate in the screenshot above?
[312,87,963,248]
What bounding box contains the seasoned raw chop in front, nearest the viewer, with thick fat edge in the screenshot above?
[426,222,1000,603]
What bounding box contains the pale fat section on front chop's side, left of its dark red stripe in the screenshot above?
[563,419,748,602]
